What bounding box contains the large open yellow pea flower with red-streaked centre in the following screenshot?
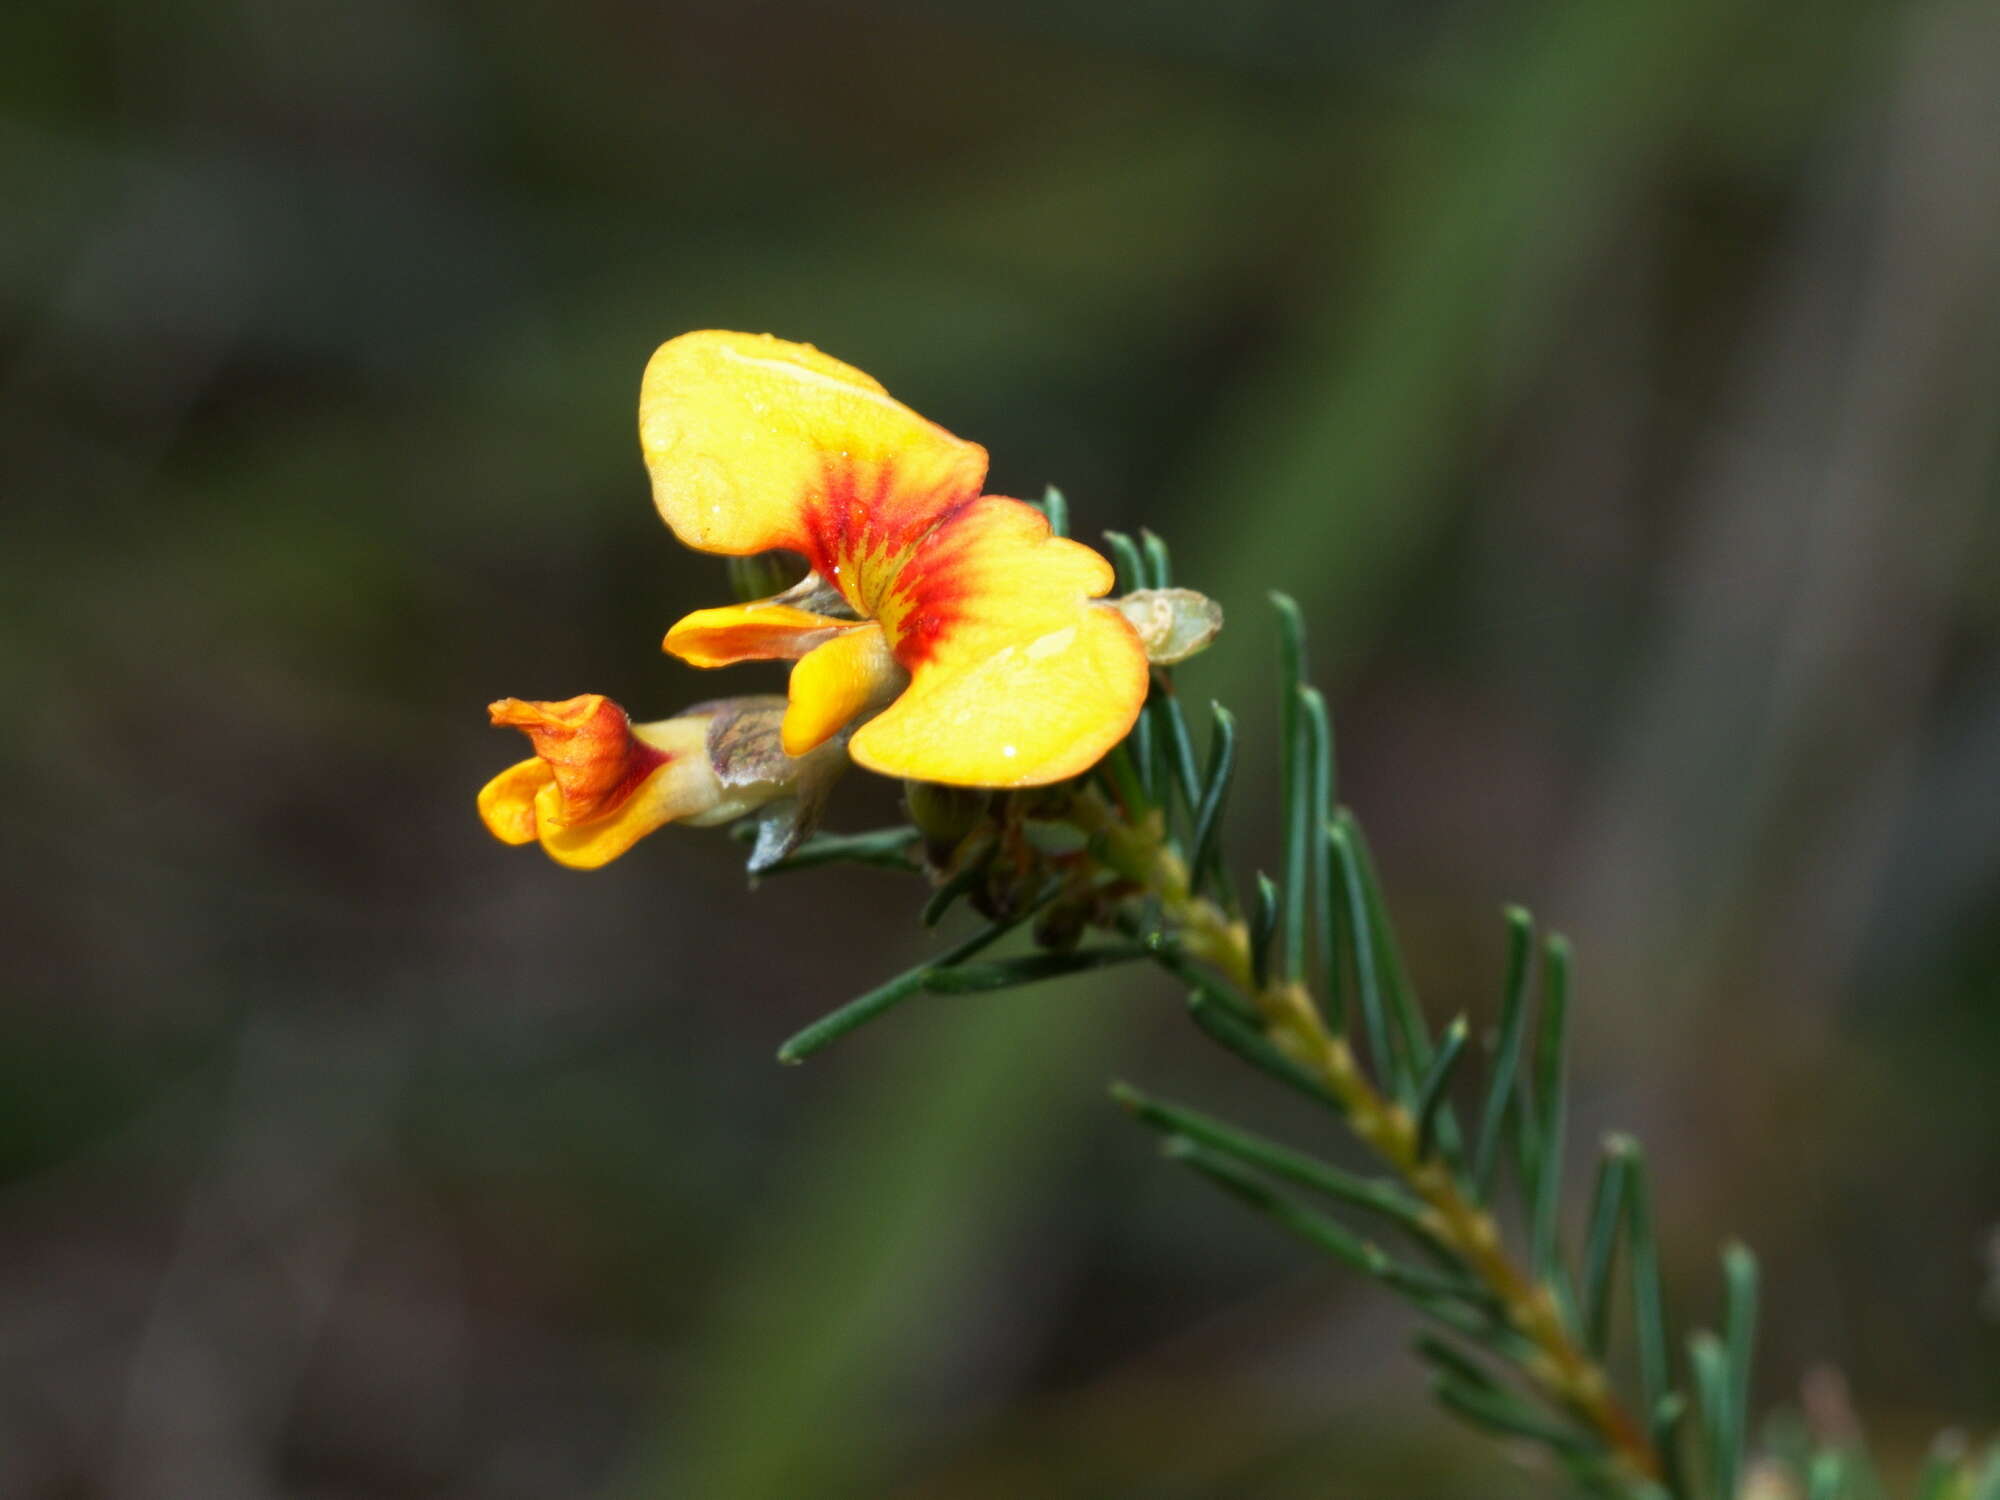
[638,332,1146,786]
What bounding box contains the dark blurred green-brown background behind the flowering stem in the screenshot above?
[0,0,2000,1500]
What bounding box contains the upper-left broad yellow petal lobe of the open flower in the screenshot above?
[638,330,986,592]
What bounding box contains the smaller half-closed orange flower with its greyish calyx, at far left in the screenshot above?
[480,692,844,870]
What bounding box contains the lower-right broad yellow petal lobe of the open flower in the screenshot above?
[852,496,1148,786]
